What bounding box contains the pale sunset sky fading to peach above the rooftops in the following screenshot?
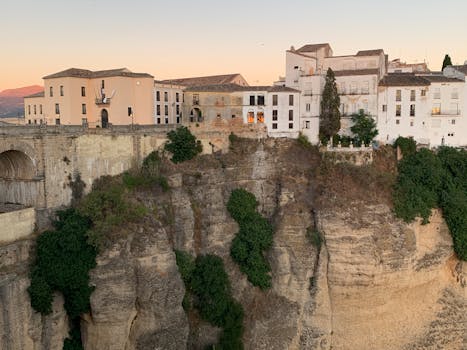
[0,0,467,91]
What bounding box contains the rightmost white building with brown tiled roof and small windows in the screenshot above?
[377,73,467,147]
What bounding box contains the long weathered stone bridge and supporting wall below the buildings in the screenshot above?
[0,121,265,227]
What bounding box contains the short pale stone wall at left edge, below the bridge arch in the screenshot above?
[0,208,36,244]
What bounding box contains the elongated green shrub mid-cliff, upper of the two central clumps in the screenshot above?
[227,189,274,289]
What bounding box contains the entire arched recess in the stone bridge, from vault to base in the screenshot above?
[0,150,42,212]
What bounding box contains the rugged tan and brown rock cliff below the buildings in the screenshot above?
[0,140,467,350]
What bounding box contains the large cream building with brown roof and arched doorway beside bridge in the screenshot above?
[24,68,154,128]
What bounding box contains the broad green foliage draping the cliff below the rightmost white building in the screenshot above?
[394,147,467,260]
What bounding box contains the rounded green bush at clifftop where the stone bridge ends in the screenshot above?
[164,126,203,163]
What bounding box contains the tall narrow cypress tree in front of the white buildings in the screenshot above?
[319,68,341,142]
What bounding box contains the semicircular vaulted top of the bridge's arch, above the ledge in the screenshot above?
[0,150,34,180]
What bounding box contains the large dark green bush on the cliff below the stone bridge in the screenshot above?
[28,209,97,318]
